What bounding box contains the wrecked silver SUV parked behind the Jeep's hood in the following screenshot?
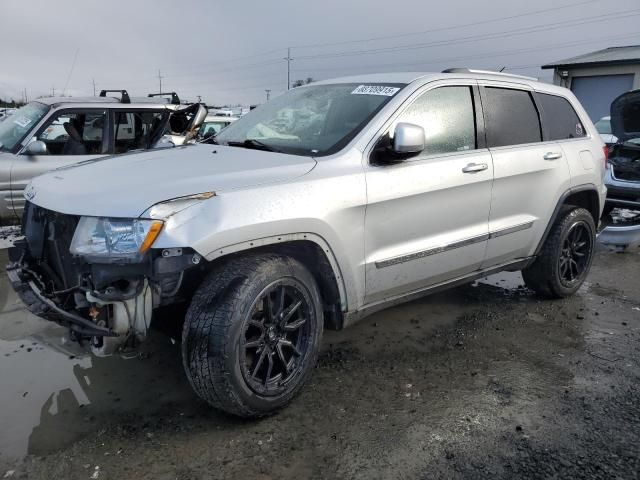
[0,90,206,223]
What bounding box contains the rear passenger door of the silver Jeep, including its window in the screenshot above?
[479,81,570,268]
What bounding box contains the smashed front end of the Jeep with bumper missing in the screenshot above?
[7,203,201,356]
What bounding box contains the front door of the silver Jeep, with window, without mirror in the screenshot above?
[365,81,493,304]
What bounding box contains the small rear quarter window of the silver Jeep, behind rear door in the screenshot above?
[537,93,587,140]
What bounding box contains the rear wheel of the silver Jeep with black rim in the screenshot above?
[522,207,596,298]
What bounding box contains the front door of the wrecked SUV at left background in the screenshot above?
[11,109,108,217]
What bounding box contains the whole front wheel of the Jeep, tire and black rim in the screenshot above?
[182,255,323,417]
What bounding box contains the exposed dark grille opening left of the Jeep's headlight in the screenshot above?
[22,202,80,291]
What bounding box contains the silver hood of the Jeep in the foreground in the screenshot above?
[25,145,316,217]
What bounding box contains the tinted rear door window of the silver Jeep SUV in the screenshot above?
[482,87,542,147]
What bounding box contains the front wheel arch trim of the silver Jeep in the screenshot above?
[206,233,348,330]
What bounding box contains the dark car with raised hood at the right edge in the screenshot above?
[604,90,640,218]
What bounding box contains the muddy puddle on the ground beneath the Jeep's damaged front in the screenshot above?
[0,250,197,460]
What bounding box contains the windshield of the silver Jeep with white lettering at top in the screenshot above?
[216,83,404,157]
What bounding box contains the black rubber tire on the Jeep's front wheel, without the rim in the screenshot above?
[182,254,323,417]
